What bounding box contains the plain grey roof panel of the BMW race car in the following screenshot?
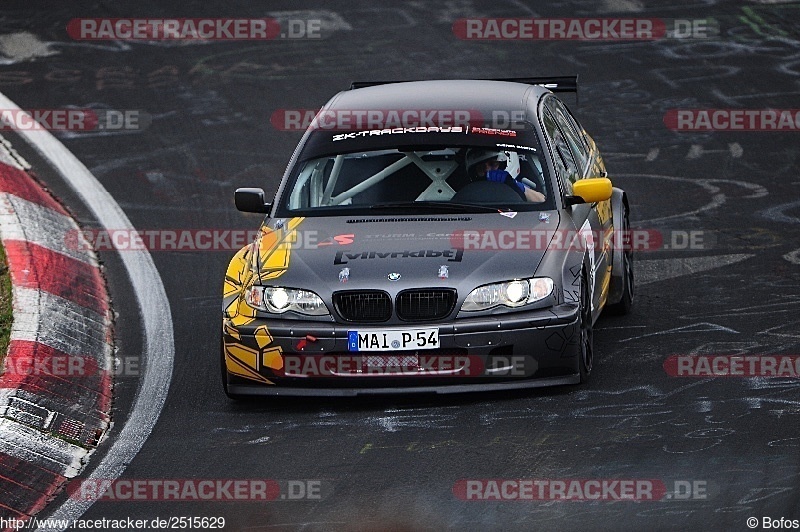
[326,80,550,118]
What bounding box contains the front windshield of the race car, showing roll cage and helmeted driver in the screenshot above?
[280,139,553,216]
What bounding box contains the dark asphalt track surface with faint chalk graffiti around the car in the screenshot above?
[0,0,800,530]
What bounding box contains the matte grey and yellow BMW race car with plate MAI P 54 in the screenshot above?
[220,77,634,399]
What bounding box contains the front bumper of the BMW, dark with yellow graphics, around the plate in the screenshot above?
[223,304,580,396]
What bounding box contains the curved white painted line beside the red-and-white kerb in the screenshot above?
[0,93,175,530]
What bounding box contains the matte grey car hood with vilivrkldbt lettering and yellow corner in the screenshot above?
[253,211,560,300]
